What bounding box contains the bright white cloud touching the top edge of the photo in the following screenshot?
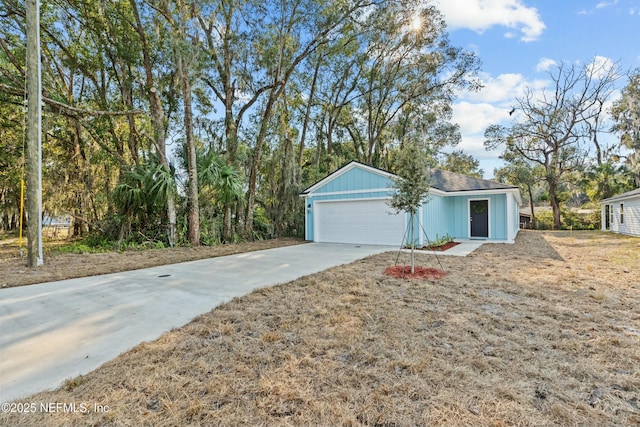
[439,0,546,42]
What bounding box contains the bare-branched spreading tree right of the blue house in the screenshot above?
[485,60,619,228]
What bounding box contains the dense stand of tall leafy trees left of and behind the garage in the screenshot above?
[0,0,479,245]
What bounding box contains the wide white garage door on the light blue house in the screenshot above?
[314,200,406,246]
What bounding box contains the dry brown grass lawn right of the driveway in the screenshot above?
[0,232,640,426]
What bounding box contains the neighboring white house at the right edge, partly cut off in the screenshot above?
[600,188,640,236]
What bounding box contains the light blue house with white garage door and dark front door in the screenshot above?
[301,161,521,246]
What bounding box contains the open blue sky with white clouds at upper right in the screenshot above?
[434,0,640,178]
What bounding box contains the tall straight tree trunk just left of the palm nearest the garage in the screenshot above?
[177,53,200,246]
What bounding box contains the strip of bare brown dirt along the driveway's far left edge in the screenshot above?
[0,236,304,288]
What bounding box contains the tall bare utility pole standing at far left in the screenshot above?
[26,0,44,267]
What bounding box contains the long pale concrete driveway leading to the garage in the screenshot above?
[0,243,397,402]
